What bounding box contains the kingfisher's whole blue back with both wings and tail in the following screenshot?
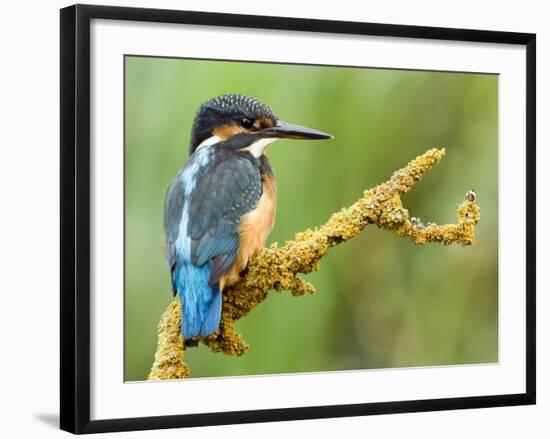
[164,147,262,339]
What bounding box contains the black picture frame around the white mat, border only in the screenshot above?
[60,5,536,434]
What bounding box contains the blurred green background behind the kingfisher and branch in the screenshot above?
[125,56,498,381]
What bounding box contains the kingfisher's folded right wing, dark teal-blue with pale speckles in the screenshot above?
[187,153,262,285]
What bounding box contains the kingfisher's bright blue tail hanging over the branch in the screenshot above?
[173,264,222,339]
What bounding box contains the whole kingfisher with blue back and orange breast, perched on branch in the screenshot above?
[164,94,332,340]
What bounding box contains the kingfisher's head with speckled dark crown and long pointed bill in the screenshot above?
[189,94,332,157]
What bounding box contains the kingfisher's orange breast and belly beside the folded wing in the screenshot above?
[220,175,277,291]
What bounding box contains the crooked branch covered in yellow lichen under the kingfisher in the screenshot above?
[149,149,479,380]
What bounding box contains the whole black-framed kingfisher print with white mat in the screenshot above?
[61,5,535,433]
